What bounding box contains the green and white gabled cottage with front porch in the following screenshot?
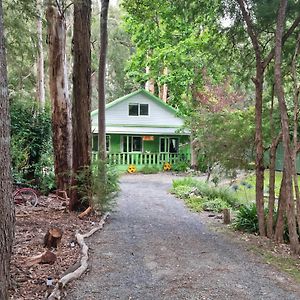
[91,89,190,171]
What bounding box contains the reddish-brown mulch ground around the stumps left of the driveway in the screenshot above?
[10,195,99,300]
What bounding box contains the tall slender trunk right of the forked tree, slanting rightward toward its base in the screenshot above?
[274,0,299,253]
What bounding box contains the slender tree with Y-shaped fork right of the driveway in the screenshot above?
[235,0,300,235]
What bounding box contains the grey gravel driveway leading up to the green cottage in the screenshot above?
[67,174,300,300]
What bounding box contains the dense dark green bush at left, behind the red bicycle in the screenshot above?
[11,99,54,189]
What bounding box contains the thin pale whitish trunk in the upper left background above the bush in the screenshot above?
[37,0,45,108]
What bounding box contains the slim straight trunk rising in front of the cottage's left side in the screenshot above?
[98,0,109,161]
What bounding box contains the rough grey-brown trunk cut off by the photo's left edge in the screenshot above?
[0,1,14,300]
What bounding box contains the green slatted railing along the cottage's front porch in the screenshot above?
[93,152,190,165]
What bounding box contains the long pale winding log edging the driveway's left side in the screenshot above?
[47,213,109,300]
